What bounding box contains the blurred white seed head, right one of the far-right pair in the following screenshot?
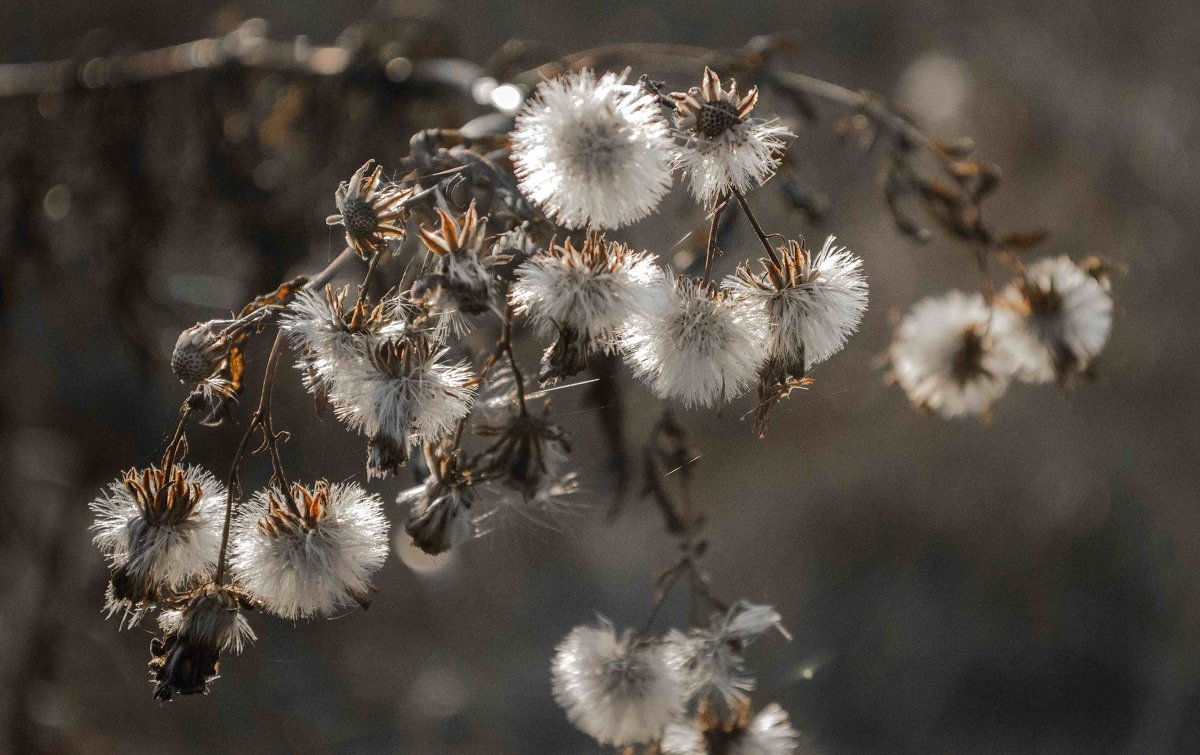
[1001,257,1112,384]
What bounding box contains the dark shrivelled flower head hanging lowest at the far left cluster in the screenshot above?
[150,582,254,701]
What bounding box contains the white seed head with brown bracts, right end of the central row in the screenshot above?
[726,236,868,372]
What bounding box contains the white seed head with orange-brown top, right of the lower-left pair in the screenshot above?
[229,480,389,619]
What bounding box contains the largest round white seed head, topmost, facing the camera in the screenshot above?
[512,71,672,228]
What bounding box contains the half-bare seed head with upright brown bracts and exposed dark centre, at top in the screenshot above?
[670,67,792,208]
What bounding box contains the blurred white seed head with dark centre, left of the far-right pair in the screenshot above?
[890,290,1016,418]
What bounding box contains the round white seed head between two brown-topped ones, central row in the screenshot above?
[623,275,767,407]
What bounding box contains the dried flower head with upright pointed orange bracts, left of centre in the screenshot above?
[409,202,503,332]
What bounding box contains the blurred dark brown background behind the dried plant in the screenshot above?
[0,0,1200,753]
